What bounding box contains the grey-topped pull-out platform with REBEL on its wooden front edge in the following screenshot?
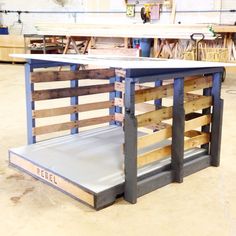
[9,126,209,209]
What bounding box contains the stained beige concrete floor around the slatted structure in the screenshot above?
[0,64,236,236]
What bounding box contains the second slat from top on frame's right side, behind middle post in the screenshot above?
[136,97,212,127]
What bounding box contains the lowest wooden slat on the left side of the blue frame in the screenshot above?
[33,116,114,135]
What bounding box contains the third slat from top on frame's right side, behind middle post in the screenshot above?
[137,115,211,149]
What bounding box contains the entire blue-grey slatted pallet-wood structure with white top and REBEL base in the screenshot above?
[9,54,229,210]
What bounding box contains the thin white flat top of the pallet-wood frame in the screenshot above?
[10,54,236,69]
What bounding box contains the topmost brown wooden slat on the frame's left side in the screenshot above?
[31,69,115,83]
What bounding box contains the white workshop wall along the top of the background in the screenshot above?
[0,0,236,34]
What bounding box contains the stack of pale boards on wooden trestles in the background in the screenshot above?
[35,23,215,58]
